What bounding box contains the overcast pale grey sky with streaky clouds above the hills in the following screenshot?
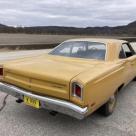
[0,0,136,27]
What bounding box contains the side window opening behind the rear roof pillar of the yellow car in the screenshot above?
[119,43,134,58]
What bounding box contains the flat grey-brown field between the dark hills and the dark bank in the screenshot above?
[0,34,136,45]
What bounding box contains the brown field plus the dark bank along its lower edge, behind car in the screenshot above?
[0,34,136,51]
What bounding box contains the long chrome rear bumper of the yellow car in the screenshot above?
[0,82,88,119]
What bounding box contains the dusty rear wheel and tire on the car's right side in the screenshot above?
[99,93,117,117]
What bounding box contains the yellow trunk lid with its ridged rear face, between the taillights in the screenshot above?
[4,55,101,100]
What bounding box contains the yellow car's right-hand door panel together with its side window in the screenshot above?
[120,43,136,83]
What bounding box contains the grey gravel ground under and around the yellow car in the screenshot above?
[0,49,136,136]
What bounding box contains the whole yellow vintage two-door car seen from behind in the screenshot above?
[0,39,136,119]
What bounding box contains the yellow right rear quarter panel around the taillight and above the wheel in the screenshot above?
[71,65,124,113]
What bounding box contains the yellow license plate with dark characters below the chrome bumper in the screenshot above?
[24,96,40,109]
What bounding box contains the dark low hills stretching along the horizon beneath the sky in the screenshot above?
[0,21,136,36]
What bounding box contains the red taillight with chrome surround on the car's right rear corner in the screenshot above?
[72,83,83,99]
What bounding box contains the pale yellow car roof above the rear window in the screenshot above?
[66,38,127,44]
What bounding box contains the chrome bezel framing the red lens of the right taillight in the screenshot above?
[72,82,83,100]
